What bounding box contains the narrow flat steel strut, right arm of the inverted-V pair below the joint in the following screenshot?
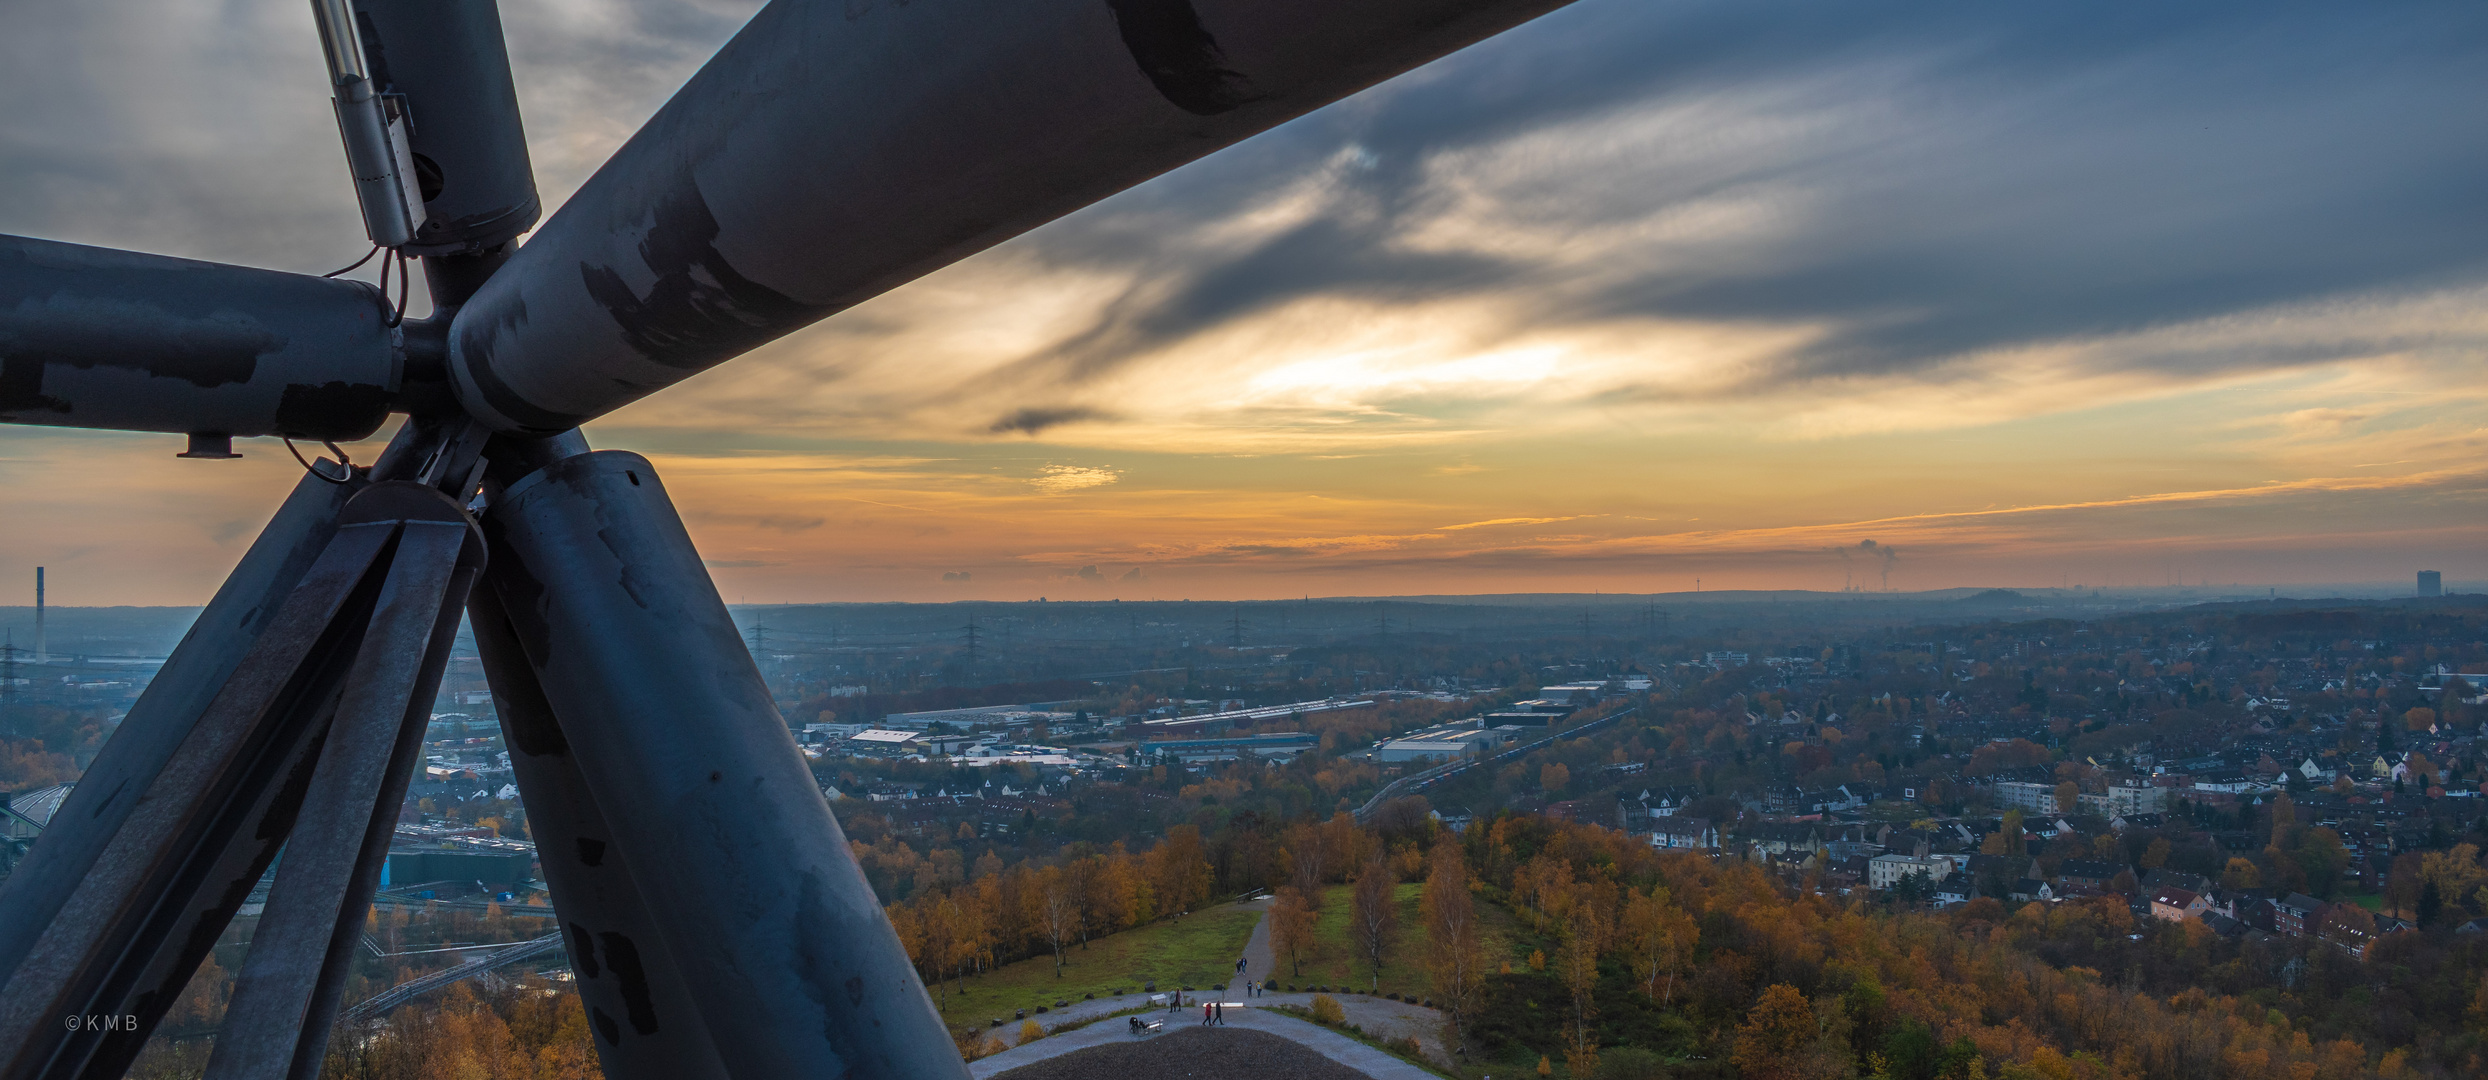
[207,483,483,1080]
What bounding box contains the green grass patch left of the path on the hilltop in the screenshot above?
[928,903,1261,1030]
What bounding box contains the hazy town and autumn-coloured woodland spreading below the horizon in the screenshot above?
[0,587,2488,1078]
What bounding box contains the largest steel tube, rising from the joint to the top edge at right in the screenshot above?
[448,0,1567,435]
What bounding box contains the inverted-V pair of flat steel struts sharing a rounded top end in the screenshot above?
[0,480,483,1078]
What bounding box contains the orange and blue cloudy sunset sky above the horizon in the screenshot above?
[0,0,2488,605]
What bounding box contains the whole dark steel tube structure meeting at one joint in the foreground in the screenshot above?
[0,0,1565,1080]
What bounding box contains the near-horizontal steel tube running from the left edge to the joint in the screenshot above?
[0,236,401,440]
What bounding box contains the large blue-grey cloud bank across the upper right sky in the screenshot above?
[995,0,2488,388]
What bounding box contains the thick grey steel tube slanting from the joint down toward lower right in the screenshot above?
[483,450,968,1080]
